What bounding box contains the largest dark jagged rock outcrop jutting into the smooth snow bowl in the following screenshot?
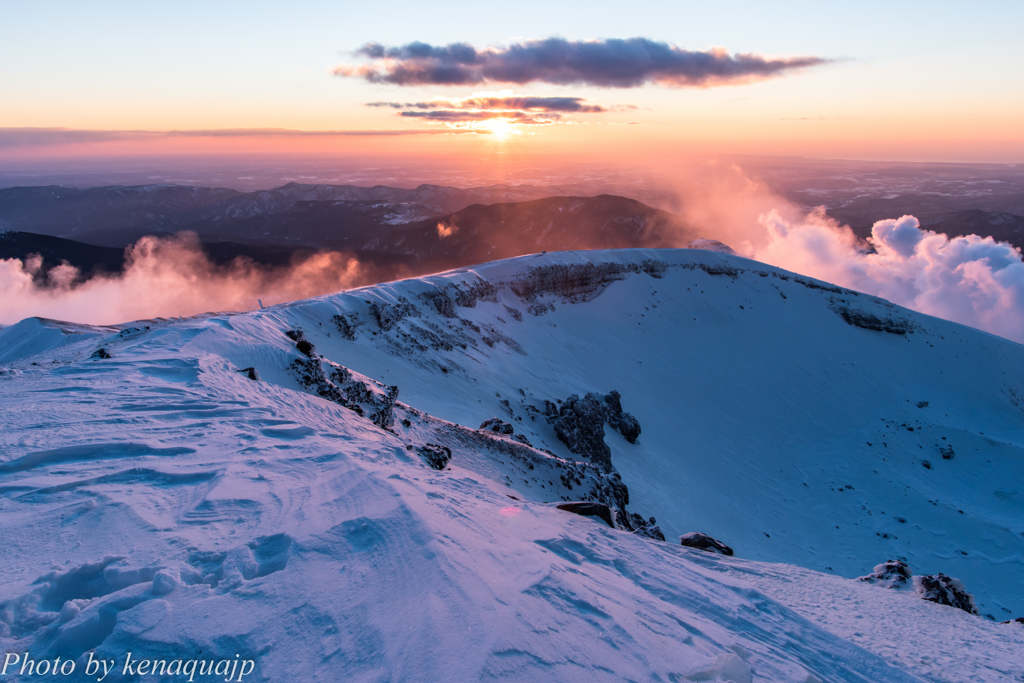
[545,391,640,471]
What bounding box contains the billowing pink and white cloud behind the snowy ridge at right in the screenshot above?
[667,166,1024,343]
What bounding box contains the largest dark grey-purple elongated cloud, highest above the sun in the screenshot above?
[334,38,829,88]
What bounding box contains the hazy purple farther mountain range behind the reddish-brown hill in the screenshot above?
[0,182,606,249]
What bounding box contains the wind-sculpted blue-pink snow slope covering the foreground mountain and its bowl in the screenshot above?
[0,250,1024,683]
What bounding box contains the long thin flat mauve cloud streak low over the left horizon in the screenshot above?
[0,128,475,150]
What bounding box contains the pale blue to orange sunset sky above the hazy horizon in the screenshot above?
[0,0,1024,164]
